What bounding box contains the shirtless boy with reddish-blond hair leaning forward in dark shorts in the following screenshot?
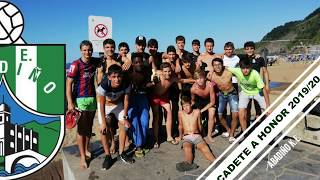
[190,71,216,142]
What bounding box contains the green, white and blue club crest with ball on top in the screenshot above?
[0,1,65,179]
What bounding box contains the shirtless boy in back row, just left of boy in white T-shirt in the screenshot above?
[196,38,220,74]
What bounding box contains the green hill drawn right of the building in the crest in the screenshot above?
[22,120,60,156]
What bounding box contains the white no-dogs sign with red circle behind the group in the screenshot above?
[88,16,112,53]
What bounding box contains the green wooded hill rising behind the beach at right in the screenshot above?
[250,8,320,53]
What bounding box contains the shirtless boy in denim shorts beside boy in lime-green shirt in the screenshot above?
[211,58,238,143]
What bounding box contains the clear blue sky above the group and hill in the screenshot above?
[10,0,320,62]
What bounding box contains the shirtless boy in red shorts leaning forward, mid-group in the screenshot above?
[151,62,186,148]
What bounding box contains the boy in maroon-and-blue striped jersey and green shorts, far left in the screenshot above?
[66,40,99,169]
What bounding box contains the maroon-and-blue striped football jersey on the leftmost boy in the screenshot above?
[68,58,97,98]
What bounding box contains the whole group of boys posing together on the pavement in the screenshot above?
[66,36,270,171]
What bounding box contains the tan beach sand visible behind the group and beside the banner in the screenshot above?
[24,60,318,180]
